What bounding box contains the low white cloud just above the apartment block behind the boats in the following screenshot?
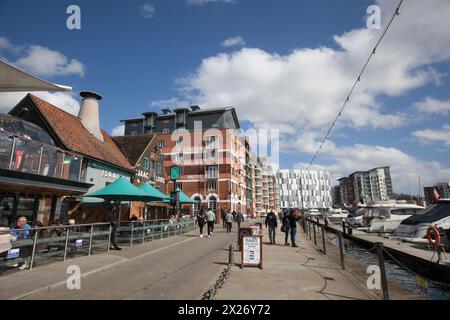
[296,144,450,193]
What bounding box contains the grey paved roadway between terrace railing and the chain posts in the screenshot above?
[0,225,243,300]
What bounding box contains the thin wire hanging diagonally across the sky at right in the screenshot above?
[306,0,404,171]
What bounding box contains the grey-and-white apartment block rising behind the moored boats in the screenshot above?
[338,167,393,206]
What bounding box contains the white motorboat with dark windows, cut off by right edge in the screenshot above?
[392,199,450,243]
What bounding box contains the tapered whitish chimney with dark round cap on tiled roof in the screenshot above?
[78,92,104,142]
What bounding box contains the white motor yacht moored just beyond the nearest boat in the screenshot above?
[357,201,424,233]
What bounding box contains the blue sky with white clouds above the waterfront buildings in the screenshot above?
[0,0,450,191]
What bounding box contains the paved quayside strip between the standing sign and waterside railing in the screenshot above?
[214,228,377,300]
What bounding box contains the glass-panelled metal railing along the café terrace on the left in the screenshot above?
[0,219,196,275]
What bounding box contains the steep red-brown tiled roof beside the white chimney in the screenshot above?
[28,94,132,170]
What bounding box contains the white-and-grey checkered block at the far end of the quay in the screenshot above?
[277,170,332,209]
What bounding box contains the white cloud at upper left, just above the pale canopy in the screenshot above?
[14,45,85,77]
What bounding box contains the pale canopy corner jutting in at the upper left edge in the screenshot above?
[0,59,72,92]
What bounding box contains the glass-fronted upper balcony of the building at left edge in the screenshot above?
[0,132,83,182]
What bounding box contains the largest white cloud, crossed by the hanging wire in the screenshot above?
[180,0,450,130]
